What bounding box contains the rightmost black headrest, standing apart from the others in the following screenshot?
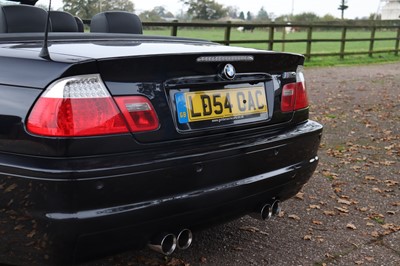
[90,11,143,34]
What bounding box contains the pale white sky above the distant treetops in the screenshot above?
[39,0,381,19]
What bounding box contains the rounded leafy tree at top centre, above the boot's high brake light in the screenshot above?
[181,0,228,20]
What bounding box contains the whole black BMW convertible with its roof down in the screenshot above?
[0,0,322,265]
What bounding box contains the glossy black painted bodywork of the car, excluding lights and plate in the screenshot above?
[0,31,322,265]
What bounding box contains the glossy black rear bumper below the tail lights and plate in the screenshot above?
[0,121,322,264]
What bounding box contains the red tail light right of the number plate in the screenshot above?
[281,66,308,112]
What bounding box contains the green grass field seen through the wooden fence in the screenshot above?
[144,28,400,65]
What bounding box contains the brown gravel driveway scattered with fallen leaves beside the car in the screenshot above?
[86,63,400,266]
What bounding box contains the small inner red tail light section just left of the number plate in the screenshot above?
[115,96,159,132]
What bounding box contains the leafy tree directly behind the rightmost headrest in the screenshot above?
[63,0,134,19]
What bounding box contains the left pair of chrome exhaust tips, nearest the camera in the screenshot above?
[148,229,193,256]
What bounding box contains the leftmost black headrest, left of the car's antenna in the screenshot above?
[0,5,51,33]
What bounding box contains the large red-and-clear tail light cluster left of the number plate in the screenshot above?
[27,74,158,137]
